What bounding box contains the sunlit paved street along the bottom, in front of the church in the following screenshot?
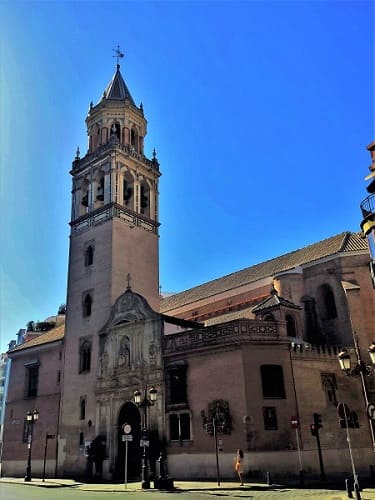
[0,478,375,500]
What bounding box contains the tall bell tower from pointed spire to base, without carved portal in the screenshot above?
[58,59,160,473]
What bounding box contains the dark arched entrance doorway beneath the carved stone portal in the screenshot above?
[116,402,142,481]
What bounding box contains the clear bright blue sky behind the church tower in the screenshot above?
[0,0,375,351]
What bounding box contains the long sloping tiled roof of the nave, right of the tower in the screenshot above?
[160,232,368,312]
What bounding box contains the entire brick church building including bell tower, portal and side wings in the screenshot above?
[2,60,375,480]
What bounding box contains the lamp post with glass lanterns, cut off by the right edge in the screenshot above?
[337,332,375,452]
